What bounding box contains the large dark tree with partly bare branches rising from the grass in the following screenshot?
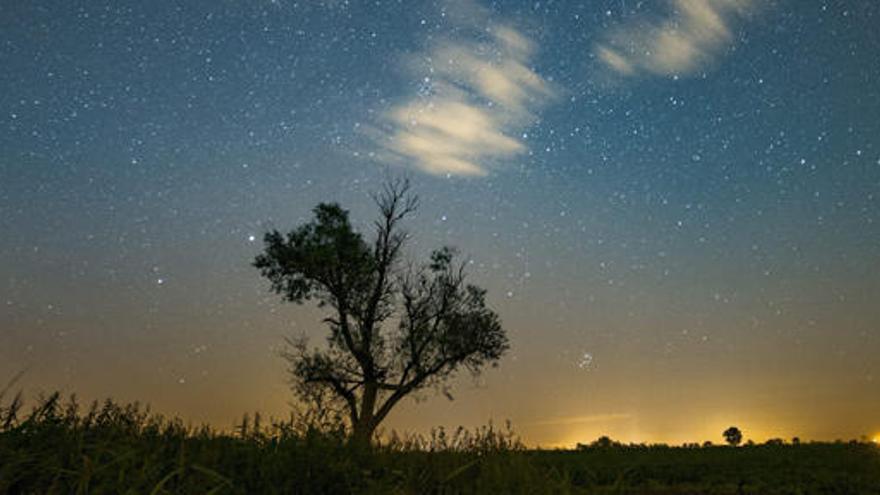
[254,179,508,445]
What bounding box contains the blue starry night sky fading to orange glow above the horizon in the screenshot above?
[0,0,880,446]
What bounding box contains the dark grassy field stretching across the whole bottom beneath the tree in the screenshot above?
[0,395,880,494]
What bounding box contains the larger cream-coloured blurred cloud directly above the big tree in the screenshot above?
[371,13,556,176]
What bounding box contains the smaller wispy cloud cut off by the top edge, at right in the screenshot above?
[595,0,758,76]
